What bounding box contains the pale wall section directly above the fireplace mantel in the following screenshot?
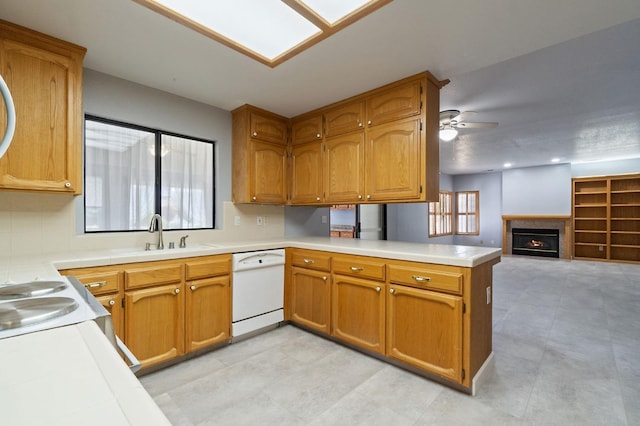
[502,164,571,215]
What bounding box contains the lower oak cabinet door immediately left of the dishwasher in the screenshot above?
[185,275,231,352]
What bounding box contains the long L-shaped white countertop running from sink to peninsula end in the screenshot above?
[0,237,502,285]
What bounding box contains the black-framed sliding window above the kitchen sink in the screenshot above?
[84,115,215,233]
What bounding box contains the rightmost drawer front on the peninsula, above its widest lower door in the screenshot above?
[389,265,462,294]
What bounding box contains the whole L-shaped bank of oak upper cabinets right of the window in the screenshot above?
[233,72,446,205]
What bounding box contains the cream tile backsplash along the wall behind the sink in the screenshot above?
[0,191,284,256]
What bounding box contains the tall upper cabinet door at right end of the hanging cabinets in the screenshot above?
[365,120,424,202]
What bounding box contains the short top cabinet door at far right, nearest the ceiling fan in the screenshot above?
[367,80,422,126]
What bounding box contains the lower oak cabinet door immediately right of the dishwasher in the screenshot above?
[291,266,331,334]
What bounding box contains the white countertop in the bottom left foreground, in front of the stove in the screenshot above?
[0,321,170,426]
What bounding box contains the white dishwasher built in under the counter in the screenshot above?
[231,249,285,337]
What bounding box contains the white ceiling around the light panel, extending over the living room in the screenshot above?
[0,0,640,174]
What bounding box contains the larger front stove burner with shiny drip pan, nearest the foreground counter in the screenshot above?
[0,297,78,330]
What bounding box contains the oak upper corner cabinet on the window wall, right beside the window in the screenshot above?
[232,105,288,204]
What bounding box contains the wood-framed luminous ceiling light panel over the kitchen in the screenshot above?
[134,0,392,67]
